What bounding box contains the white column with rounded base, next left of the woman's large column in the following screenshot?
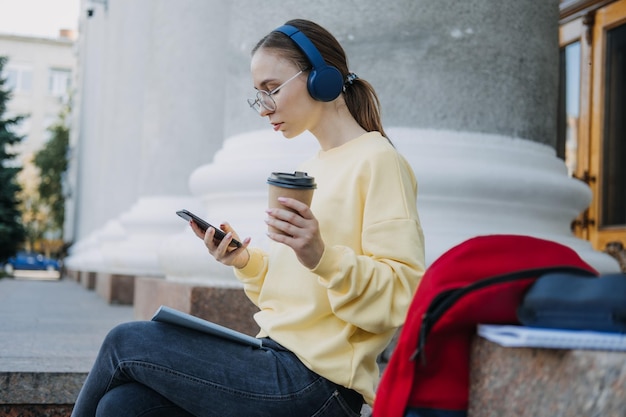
[92,0,228,276]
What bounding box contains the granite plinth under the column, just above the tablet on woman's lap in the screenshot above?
[134,277,259,336]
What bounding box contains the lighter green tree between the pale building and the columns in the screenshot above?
[34,105,70,233]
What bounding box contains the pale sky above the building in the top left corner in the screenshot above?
[0,0,80,38]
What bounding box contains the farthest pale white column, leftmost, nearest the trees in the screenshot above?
[66,0,152,280]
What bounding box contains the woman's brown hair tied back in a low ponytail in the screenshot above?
[252,19,387,137]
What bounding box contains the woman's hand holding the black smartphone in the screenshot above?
[189,220,250,269]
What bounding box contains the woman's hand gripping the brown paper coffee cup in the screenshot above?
[265,197,324,269]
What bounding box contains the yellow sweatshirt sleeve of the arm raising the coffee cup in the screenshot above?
[312,152,425,333]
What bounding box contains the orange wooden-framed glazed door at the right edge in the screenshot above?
[557,0,626,250]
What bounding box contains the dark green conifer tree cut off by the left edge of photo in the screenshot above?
[0,56,25,261]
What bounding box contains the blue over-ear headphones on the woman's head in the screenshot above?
[274,25,343,101]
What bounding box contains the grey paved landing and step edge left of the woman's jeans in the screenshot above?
[0,274,134,417]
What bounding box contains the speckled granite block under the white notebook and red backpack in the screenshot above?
[469,337,626,417]
